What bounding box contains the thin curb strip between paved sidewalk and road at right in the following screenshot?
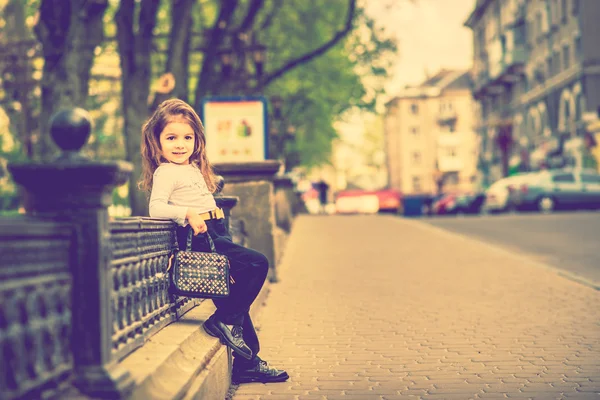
[392,217,600,290]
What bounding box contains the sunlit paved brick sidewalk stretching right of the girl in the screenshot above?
[233,215,600,400]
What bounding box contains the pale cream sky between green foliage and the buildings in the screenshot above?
[366,0,475,96]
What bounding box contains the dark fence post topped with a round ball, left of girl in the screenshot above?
[9,108,134,398]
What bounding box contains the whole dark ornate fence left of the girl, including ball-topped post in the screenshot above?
[0,109,243,399]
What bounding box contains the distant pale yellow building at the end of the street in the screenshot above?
[384,70,478,194]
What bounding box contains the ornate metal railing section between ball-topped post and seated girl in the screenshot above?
[110,218,201,359]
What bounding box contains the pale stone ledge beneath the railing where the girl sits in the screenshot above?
[120,300,231,399]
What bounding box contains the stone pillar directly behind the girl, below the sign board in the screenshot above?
[213,160,281,282]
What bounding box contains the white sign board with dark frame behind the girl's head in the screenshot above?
[201,96,268,163]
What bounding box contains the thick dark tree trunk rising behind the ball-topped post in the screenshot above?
[35,0,108,158]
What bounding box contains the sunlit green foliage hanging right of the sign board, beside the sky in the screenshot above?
[255,0,396,167]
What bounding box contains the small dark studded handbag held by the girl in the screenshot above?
[169,229,233,299]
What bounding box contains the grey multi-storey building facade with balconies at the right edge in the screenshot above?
[465,0,600,183]
